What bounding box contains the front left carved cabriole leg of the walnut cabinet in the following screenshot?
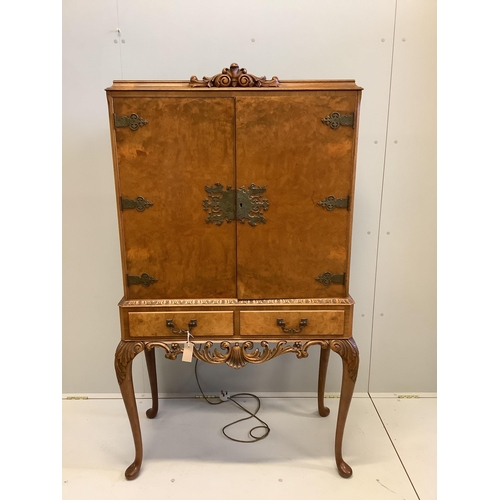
[115,340,144,479]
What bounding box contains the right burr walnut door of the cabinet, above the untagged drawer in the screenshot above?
[236,92,357,299]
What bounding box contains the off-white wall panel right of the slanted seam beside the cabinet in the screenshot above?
[370,0,436,392]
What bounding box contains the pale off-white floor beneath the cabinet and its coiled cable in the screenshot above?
[62,394,437,500]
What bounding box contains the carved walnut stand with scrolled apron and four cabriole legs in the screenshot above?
[115,337,359,479]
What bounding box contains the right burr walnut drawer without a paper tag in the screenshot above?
[240,310,344,337]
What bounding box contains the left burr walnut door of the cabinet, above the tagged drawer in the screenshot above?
[112,97,236,299]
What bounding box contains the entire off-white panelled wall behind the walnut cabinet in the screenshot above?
[63,0,436,393]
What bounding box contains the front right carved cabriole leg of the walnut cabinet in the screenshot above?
[330,338,359,477]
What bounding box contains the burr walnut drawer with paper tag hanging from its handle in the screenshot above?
[128,311,234,339]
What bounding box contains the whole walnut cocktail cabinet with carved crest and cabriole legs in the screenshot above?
[106,64,361,479]
